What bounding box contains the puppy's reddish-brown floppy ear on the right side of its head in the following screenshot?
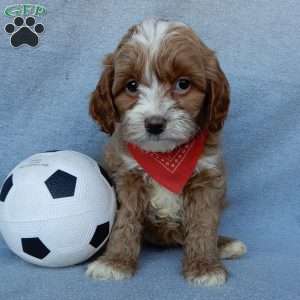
[205,55,230,132]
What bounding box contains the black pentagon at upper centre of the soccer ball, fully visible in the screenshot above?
[45,170,77,199]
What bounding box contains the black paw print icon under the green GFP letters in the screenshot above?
[4,16,45,48]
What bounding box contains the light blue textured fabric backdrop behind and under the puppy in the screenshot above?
[0,0,300,300]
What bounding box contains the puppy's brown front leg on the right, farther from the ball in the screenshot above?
[183,174,227,286]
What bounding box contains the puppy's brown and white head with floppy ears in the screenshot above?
[90,19,229,152]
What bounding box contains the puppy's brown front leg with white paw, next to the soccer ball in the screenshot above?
[87,173,147,280]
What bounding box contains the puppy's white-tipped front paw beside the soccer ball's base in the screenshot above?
[86,257,136,280]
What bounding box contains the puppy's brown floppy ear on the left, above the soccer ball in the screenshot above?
[90,54,118,135]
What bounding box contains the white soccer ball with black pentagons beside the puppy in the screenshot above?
[0,151,116,267]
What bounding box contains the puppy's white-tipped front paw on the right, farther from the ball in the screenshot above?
[183,261,227,286]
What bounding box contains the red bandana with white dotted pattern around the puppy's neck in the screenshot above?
[128,131,208,193]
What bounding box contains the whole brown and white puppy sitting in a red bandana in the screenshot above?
[87,19,246,286]
